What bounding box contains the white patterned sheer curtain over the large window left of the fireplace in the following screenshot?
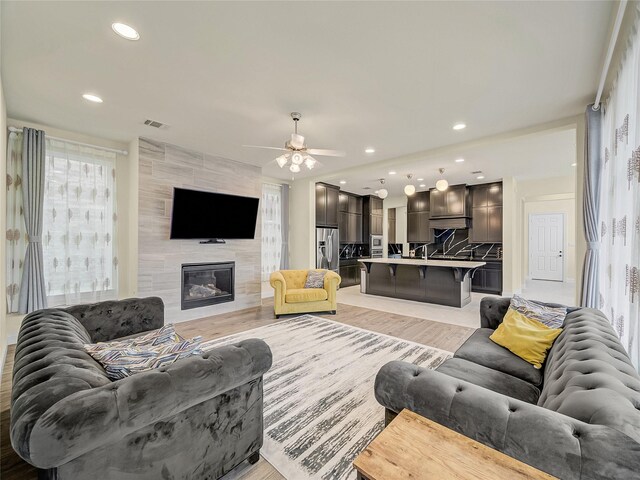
[42,139,118,306]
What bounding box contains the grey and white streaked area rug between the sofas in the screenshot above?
[204,315,451,480]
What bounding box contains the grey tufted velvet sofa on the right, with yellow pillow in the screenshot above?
[375,297,640,480]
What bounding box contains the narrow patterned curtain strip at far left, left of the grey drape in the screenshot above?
[5,132,27,313]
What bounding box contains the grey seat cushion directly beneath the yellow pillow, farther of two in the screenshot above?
[454,328,542,387]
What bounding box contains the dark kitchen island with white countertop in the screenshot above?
[361,258,486,307]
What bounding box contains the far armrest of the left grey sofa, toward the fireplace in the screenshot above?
[65,297,164,342]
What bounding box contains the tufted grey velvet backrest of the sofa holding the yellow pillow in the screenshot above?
[538,308,640,442]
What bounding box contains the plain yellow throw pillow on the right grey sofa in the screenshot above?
[489,308,562,368]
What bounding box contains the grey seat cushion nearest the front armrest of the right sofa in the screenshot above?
[436,357,540,404]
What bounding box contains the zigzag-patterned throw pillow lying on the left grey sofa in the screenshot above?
[84,324,202,380]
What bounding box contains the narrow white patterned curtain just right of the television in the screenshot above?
[262,183,282,282]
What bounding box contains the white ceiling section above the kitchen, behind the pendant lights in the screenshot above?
[323,128,576,196]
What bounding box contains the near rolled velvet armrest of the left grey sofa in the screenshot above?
[21,339,272,468]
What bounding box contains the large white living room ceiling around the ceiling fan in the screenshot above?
[0,1,615,178]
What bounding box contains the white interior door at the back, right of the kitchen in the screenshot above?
[529,213,564,282]
